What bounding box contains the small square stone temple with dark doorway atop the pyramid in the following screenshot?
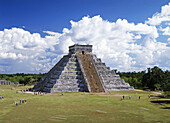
[69,44,92,54]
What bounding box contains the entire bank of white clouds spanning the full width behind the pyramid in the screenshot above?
[0,4,170,73]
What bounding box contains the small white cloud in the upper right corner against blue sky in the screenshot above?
[146,3,170,25]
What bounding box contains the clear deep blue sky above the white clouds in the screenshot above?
[0,0,169,33]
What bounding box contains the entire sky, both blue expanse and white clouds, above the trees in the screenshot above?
[0,0,170,73]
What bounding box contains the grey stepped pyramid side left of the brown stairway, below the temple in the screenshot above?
[33,54,87,93]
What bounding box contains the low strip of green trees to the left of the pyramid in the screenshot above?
[0,73,44,85]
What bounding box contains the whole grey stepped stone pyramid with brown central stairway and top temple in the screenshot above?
[33,44,134,93]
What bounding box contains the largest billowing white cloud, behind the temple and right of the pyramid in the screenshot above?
[53,16,168,71]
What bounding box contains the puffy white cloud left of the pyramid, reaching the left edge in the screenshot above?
[0,28,57,72]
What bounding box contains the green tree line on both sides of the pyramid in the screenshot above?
[0,66,170,91]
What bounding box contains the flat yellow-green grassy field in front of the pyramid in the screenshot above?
[0,85,170,123]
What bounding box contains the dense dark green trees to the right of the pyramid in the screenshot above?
[118,66,170,91]
